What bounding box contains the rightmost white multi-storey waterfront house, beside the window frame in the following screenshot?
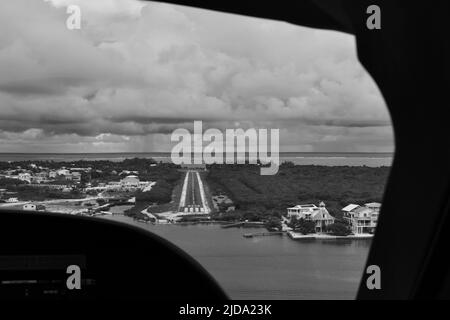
[342,202,381,234]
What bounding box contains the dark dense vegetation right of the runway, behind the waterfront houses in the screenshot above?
[207,163,389,220]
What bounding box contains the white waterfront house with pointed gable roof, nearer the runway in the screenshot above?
[287,202,334,232]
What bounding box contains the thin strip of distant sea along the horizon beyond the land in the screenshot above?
[0,152,393,167]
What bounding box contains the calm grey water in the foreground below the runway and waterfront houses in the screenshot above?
[102,216,370,299]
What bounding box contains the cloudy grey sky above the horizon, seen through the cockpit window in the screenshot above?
[0,0,393,152]
